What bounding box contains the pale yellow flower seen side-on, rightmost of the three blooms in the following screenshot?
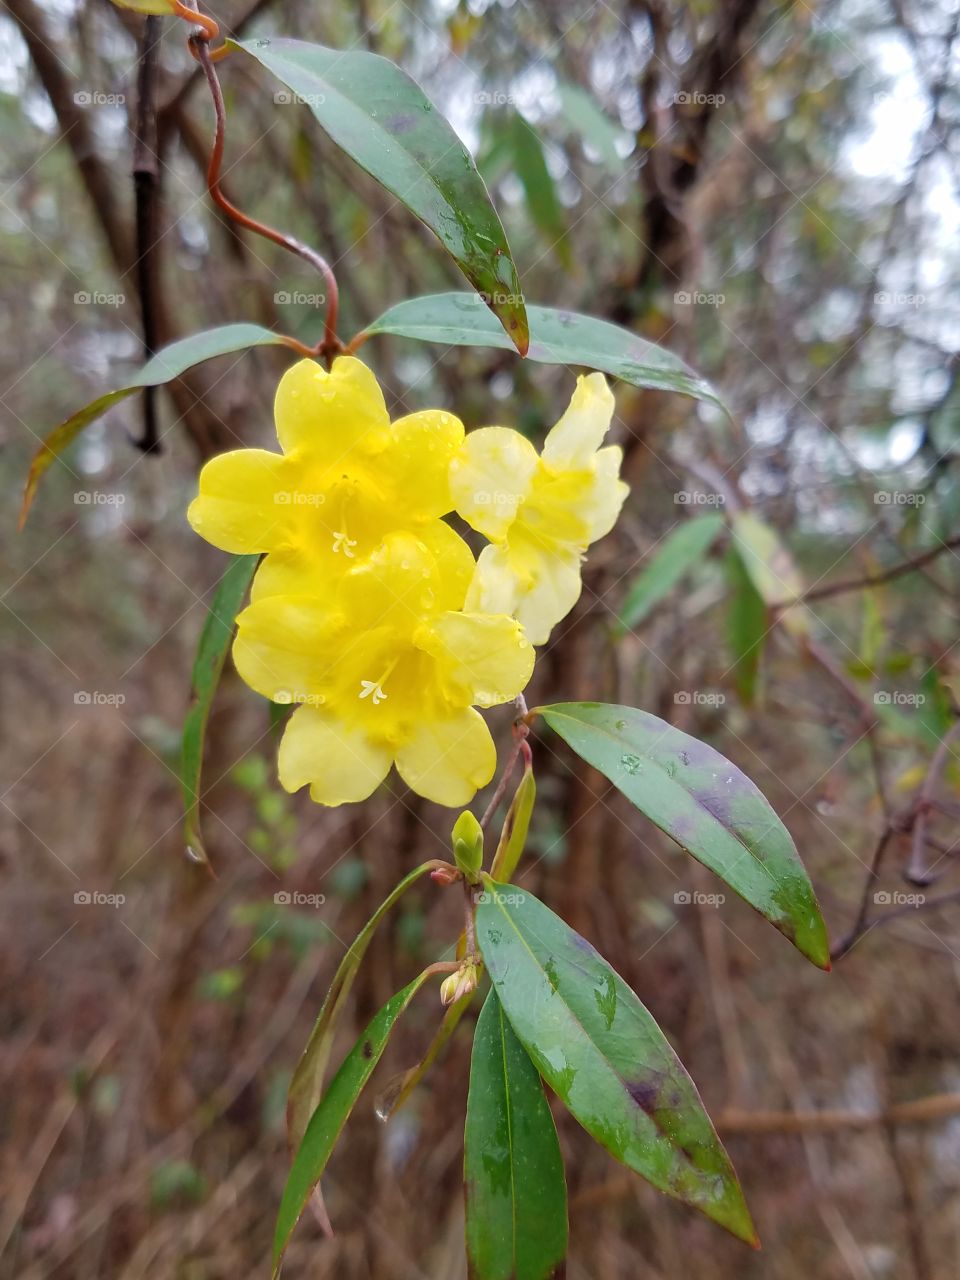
[451,374,627,644]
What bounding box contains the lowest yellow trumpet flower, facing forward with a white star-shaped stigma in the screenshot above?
[233,521,534,806]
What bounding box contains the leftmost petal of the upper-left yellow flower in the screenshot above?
[187,449,296,556]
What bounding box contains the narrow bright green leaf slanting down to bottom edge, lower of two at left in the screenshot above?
[273,969,430,1276]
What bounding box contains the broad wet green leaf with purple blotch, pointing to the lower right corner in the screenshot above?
[476,877,756,1244]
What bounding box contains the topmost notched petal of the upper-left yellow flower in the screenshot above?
[274,356,389,463]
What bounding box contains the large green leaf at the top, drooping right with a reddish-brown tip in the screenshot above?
[235,40,529,355]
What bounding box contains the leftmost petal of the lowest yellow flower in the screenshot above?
[233,595,343,705]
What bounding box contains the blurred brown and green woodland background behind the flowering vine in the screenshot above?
[0,0,960,1280]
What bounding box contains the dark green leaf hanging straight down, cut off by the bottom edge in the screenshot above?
[463,991,567,1280]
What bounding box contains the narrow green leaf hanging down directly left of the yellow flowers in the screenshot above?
[180,556,260,863]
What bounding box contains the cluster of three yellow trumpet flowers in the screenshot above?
[188,356,626,806]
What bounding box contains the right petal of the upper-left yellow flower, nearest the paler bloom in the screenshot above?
[381,408,463,520]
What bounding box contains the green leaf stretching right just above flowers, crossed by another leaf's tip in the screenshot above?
[365,293,727,412]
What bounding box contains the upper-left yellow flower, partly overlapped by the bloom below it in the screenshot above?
[187,356,463,599]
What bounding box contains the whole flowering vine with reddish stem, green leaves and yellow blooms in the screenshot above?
[23,0,829,1280]
